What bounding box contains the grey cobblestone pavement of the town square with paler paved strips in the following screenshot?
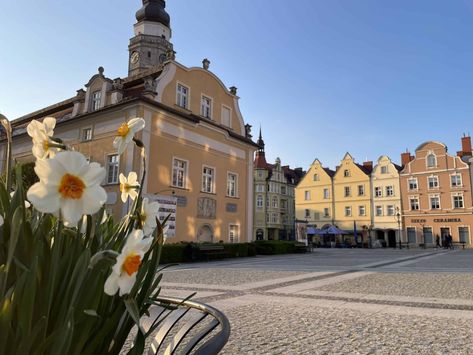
[149,249,473,354]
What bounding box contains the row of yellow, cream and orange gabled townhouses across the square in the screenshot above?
[295,136,473,247]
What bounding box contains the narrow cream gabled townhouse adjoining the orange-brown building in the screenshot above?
[369,155,402,247]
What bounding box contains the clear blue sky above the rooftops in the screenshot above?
[0,0,473,169]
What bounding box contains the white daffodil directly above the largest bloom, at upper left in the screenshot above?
[26,117,58,159]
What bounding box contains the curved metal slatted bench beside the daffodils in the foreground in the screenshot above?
[141,297,230,355]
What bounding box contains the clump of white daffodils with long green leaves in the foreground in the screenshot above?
[0,114,170,354]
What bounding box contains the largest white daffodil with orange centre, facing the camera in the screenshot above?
[26,151,107,225]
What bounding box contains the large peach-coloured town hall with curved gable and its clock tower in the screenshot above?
[0,0,257,242]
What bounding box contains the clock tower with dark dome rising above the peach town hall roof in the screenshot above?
[128,0,173,76]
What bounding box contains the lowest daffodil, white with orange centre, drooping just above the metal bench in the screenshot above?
[104,229,153,296]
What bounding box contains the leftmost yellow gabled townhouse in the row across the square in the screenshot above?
[296,159,335,229]
